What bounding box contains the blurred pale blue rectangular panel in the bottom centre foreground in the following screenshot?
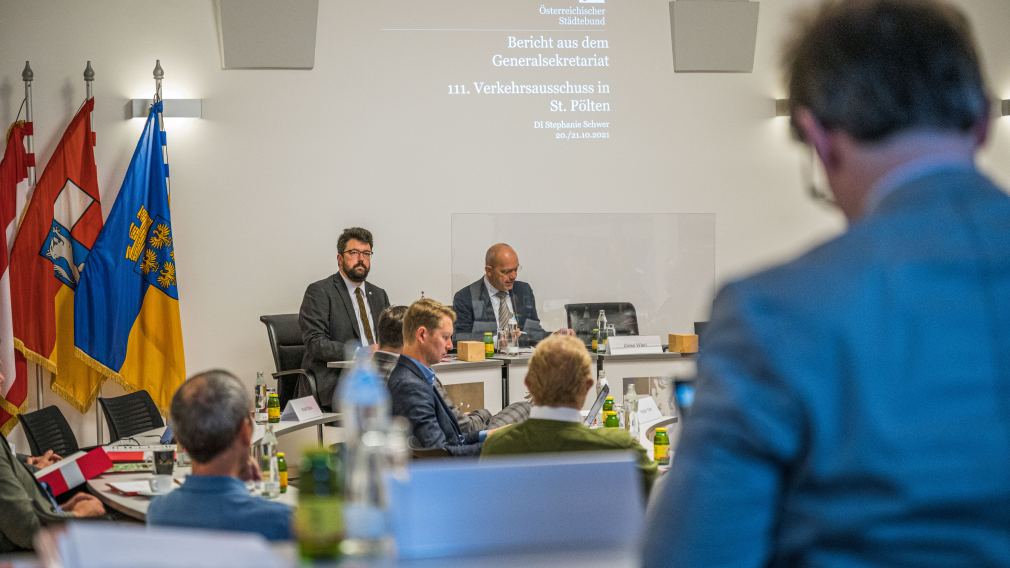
[390,452,644,559]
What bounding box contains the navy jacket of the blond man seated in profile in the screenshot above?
[387,357,481,456]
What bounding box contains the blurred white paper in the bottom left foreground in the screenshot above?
[36,523,284,568]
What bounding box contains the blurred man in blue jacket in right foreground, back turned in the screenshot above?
[644,0,1010,567]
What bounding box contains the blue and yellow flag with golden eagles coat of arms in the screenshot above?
[74,101,186,413]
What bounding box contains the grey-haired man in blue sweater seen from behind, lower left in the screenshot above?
[147,370,291,541]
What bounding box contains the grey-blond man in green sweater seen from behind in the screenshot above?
[481,336,657,493]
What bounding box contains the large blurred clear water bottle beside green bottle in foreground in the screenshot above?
[338,350,392,556]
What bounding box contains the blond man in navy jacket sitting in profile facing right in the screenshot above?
[387,298,488,456]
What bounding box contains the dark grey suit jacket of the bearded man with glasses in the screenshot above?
[298,273,389,406]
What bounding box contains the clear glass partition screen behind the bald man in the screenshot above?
[452,213,715,335]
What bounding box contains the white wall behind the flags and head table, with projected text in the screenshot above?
[0,0,1010,444]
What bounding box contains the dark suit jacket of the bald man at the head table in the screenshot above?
[452,277,548,345]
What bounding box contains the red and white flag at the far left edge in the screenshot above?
[0,121,34,436]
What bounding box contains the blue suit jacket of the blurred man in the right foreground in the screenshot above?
[644,170,1010,567]
